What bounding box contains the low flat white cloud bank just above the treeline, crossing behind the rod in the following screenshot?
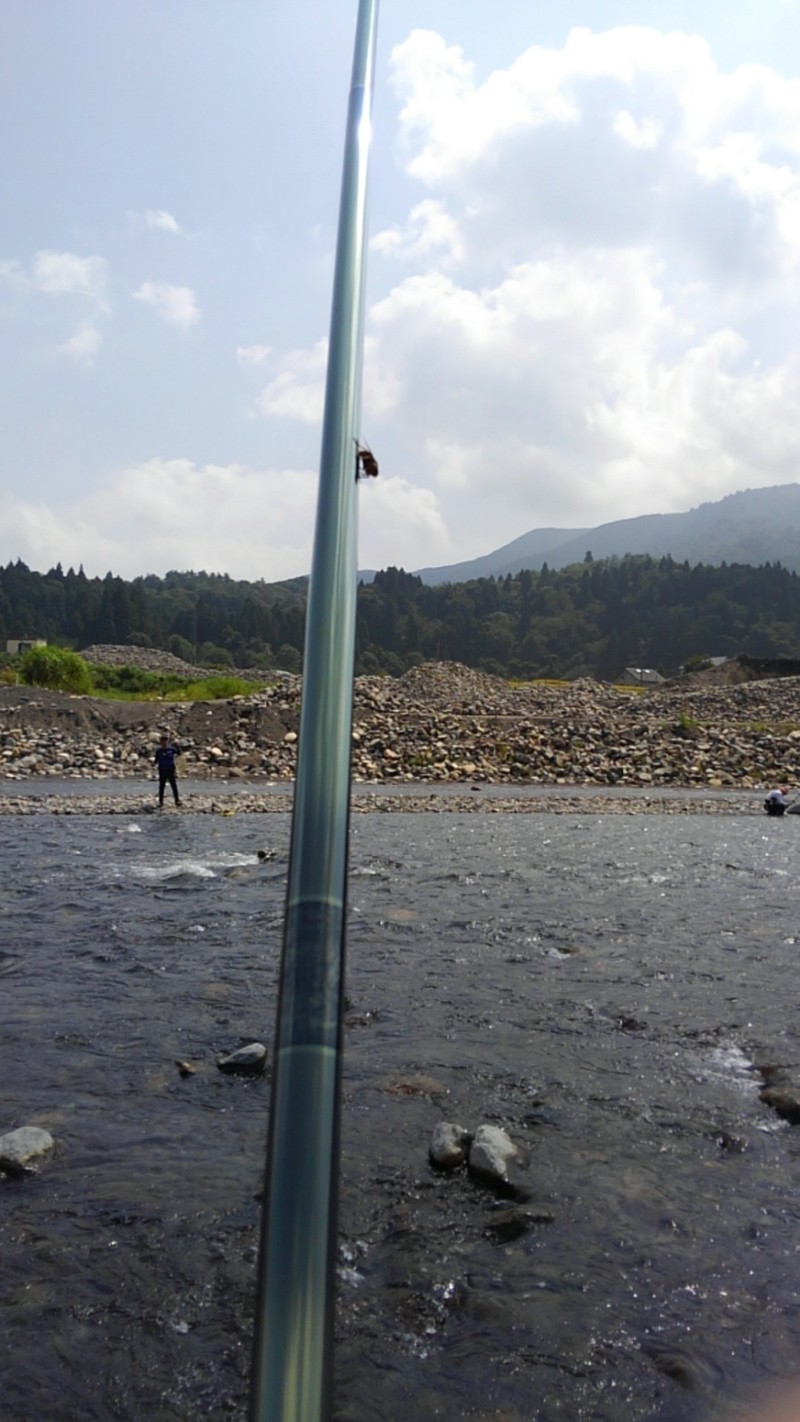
[3,458,452,582]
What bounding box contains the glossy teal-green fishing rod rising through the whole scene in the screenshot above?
[250,0,378,1422]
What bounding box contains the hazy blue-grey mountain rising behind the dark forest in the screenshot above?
[415,483,800,587]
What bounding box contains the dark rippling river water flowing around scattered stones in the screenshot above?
[0,813,800,1422]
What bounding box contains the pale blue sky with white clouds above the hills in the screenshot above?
[0,0,800,582]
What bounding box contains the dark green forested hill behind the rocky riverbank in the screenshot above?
[0,553,800,680]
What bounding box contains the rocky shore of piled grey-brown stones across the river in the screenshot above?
[0,651,800,813]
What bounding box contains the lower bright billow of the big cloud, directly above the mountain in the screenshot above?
[358,236,800,540]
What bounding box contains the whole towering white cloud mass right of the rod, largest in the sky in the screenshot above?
[352,27,800,552]
